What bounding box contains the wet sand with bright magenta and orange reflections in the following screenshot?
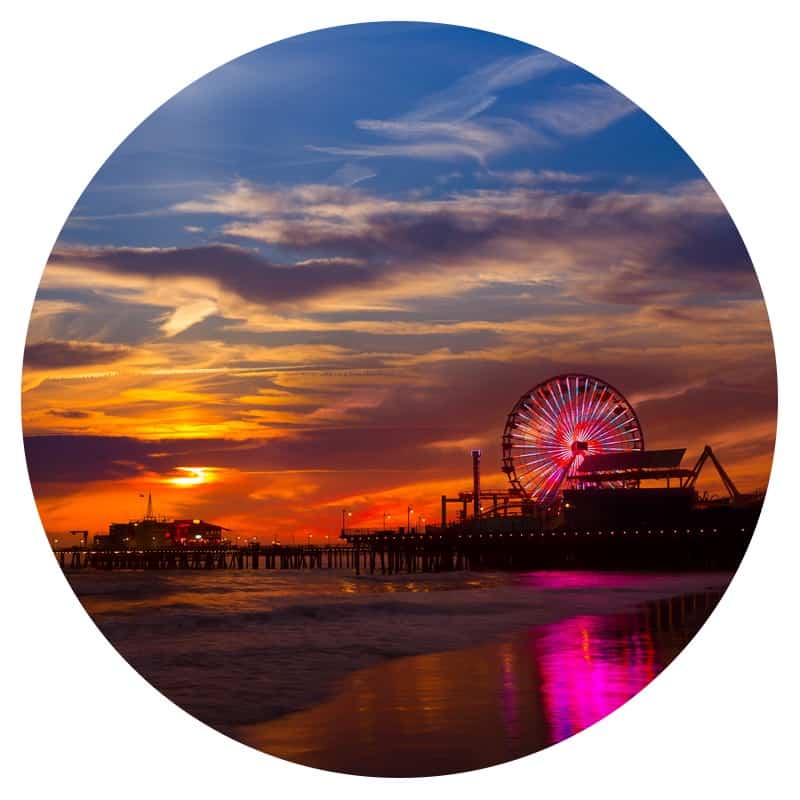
[239,592,719,776]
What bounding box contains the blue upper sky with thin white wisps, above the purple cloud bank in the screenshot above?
[62,23,700,246]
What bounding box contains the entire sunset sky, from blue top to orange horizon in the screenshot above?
[23,23,776,539]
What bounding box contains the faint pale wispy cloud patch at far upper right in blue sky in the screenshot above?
[528,83,638,136]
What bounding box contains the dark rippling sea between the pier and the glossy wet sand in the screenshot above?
[70,572,732,738]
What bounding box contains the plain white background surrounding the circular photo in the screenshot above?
[0,0,800,800]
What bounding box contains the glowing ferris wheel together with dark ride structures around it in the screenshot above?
[442,373,750,527]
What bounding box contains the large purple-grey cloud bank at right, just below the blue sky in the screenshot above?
[211,181,754,303]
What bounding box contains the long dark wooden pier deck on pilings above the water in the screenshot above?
[55,526,753,575]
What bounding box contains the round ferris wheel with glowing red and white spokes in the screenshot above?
[503,373,644,504]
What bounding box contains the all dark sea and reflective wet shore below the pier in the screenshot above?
[71,572,729,776]
